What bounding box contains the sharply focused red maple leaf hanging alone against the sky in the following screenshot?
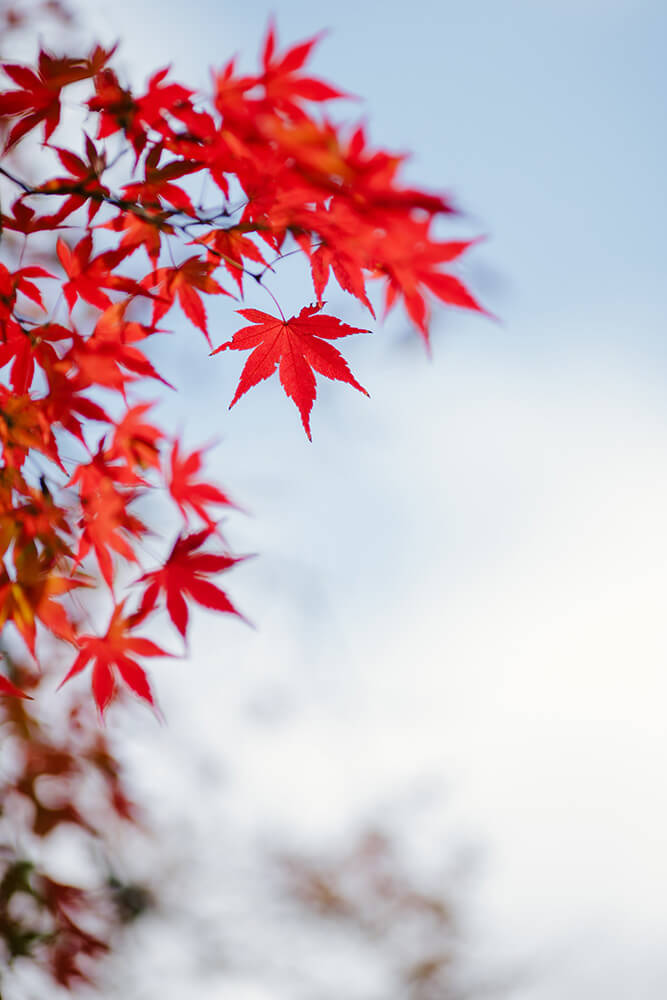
[212,303,370,440]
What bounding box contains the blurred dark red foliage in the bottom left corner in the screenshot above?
[0,654,151,1000]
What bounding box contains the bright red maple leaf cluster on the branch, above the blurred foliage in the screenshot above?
[0,21,484,712]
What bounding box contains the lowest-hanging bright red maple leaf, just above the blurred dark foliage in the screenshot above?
[60,601,171,714]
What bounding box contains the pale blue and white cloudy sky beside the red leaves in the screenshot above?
[66,0,667,1000]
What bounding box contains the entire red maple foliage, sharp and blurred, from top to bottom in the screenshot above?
[0,0,494,997]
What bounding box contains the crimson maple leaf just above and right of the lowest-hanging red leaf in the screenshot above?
[138,527,243,638]
